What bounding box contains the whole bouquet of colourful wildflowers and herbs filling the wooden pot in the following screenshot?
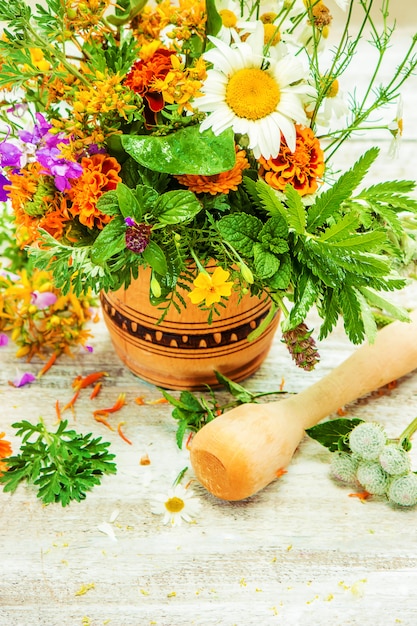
[0,0,417,366]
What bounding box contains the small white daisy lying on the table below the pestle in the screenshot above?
[151,485,200,526]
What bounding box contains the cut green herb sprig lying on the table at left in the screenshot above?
[0,418,117,507]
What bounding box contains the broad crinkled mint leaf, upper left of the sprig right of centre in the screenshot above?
[218,213,263,257]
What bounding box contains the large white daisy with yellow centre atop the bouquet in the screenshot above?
[196,22,312,159]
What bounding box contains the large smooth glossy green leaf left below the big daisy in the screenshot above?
[121,126,236,176]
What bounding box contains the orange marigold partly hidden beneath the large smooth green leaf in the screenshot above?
[175,148,249,196]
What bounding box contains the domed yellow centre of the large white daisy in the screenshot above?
[226,68,281,120]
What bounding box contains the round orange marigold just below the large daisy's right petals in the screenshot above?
[259,125,324,196]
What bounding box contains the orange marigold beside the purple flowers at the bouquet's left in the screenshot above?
[65,154,122,230]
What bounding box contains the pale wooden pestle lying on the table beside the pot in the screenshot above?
[190,310,417,500]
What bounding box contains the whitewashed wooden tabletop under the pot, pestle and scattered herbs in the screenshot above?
[0,14,417,626]
